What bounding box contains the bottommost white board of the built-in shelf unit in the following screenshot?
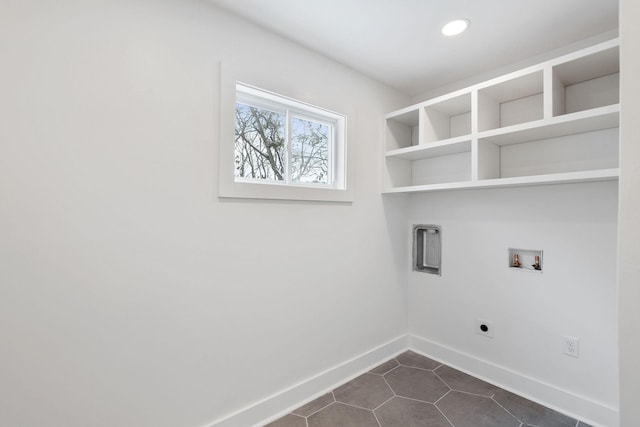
[383,168,620,194]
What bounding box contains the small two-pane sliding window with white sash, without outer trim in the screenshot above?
[234,83,346,190]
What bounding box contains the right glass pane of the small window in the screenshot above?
[291,117,331,184]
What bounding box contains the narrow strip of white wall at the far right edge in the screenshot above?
[618,0,640,427]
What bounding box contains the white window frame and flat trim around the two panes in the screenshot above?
[218,79,353,202]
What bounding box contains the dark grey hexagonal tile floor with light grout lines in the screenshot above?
[268,351,590,427]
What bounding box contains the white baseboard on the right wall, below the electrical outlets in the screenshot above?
[409,335,619,427]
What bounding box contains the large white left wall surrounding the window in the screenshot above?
[0,0,408,427]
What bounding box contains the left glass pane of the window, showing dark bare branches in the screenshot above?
[235,103,286,181]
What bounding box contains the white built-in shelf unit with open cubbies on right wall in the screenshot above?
[383,39,620,193]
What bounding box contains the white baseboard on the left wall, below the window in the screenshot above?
[207,335,409,427]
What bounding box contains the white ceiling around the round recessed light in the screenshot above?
[210,0,618,95]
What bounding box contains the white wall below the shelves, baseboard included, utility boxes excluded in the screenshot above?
[406,182,618,427]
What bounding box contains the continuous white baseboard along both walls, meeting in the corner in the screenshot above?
[207,335,619,427]
